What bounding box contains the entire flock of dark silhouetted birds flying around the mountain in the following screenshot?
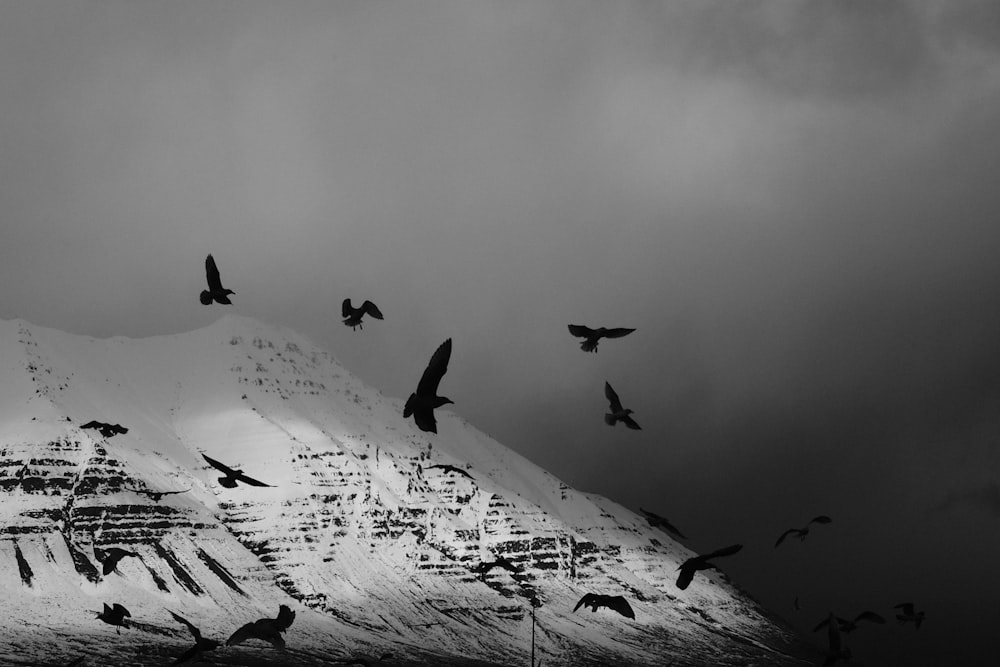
[33,255,924,667]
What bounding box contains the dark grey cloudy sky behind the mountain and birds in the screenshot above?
[0,0,1000,665]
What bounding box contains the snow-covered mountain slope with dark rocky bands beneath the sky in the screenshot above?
[0,316,803,667]
